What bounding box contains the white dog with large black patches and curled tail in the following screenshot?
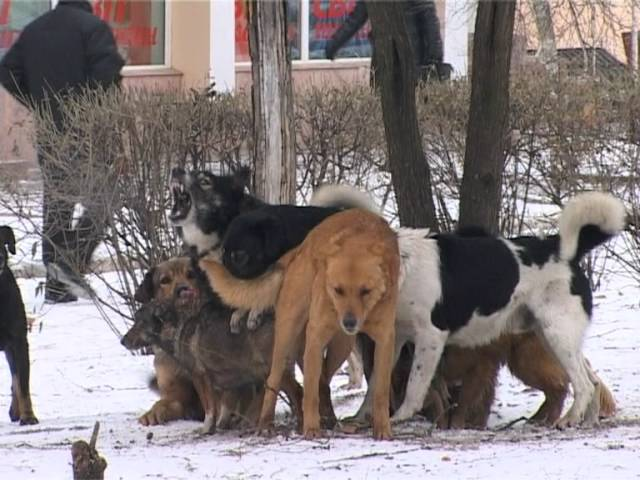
[312,186,626,427]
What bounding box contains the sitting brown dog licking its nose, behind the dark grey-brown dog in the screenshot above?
[123,258,204,426]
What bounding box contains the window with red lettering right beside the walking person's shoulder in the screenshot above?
[93,0,166,66]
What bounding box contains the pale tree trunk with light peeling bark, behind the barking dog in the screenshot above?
[247,0,296,203]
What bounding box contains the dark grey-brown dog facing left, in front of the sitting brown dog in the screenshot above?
[123,259,301,433]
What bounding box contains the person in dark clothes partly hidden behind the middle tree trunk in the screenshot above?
[325,0,451,83]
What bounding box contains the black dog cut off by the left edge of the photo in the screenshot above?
[0,227,38,425]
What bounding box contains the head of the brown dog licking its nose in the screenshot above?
[133,257,201,306]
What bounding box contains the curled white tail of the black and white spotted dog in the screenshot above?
[558,192,627,261]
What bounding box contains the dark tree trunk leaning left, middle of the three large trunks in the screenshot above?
[367,0,438,230]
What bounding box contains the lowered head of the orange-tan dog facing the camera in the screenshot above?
[325,245,387,335]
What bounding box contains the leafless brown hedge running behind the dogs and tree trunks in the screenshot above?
[0,75,640,330]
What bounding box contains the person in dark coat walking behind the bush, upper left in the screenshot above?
[0,0,124,302]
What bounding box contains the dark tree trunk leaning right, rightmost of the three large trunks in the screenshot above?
[459,0,515,233]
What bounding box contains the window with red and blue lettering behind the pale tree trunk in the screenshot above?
[235,0,371,62]
